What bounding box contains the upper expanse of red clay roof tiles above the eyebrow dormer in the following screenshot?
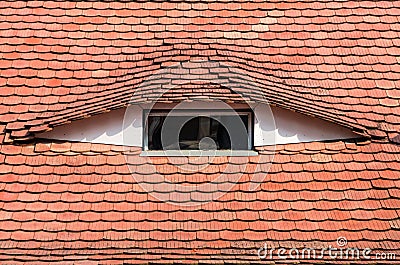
[0,1,400,141]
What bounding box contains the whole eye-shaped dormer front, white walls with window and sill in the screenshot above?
[37,102,358,156]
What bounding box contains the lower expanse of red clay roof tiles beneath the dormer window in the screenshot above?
[0,141,400,264]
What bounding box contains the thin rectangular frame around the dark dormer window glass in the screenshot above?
[142,109,254,154]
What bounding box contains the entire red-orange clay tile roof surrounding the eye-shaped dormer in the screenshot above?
[0,0,400,264]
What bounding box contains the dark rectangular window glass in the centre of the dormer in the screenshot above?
[145,111,252,150]
